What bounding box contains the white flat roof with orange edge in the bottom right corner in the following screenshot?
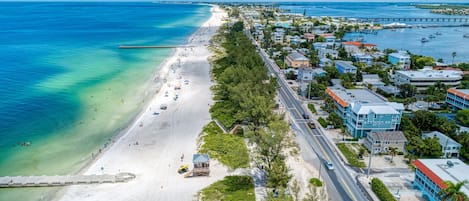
[414,159,469,195]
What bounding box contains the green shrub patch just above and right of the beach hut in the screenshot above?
[199,122,249,169]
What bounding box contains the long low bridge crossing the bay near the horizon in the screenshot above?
[349,17,469,23]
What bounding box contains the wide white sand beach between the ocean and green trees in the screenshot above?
[56,6,227,201]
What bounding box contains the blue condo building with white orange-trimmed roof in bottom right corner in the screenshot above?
[413,159,469,201]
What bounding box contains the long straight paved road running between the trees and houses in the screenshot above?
[247,30,367,201]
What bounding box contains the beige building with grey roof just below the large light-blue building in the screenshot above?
[365,131,407,154]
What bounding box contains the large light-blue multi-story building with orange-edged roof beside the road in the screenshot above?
[326,88,404,138]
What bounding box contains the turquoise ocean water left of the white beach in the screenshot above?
[0,2,210,201]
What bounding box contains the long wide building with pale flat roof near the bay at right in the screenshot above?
[394,69,462,91]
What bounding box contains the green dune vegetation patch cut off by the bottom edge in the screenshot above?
[200,176,256,201]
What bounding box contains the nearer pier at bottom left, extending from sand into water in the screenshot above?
[0,173,136,188]
